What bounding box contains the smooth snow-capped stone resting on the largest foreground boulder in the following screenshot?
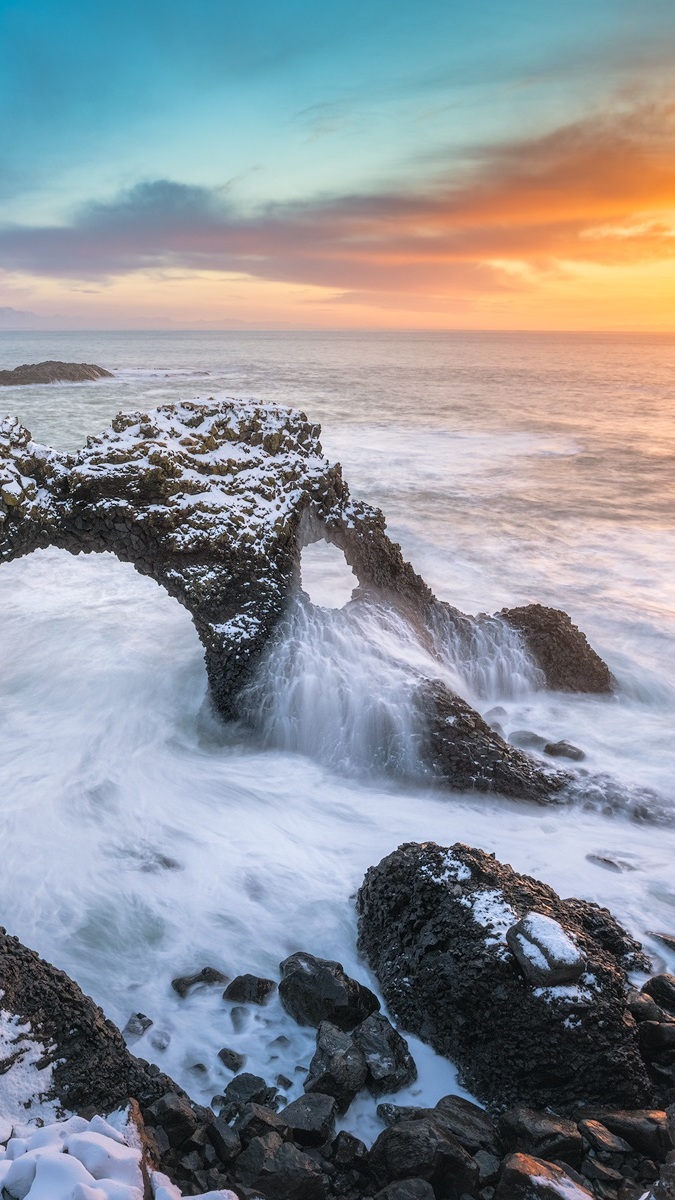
[506,912,586,988]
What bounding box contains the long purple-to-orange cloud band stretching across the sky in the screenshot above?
[0,101,675,305]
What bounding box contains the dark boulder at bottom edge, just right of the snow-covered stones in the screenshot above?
[234,1133,325,1200]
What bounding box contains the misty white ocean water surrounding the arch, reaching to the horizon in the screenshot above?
[0,332,675,1140]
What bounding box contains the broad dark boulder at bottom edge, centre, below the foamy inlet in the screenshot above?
[369,1117,478,1200]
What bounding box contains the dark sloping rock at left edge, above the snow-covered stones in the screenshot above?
[0,929,187,1120]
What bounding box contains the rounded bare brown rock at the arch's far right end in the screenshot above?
[500,604,611,694]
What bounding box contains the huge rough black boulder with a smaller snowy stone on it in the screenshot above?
[358,842,653,1112]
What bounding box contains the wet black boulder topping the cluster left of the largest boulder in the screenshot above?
[279,952,380,1031]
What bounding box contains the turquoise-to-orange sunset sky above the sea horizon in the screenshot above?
[0,0,675,331]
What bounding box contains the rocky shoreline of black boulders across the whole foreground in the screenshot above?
[0,844,675,1200]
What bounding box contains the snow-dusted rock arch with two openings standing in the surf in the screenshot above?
[0,400,610,802]
